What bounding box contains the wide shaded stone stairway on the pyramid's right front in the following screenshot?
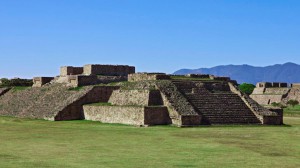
[172,80,261,124]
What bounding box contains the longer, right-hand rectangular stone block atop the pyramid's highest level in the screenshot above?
[83,64,135,76]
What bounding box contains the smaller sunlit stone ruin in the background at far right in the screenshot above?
[250,82,300,105]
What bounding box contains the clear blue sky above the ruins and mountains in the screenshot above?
[0,0,300,78]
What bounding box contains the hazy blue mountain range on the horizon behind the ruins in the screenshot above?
[174,62,300,84]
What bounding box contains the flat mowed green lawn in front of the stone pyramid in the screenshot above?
[0,117,300,168]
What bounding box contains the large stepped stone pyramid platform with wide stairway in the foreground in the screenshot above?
[0,65,282,126]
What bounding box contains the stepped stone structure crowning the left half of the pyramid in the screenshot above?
[33,64,135,87]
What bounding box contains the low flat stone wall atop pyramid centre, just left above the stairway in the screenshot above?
[128,73,170,82]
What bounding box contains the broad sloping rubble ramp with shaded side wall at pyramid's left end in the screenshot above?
[0,84,118,120]
